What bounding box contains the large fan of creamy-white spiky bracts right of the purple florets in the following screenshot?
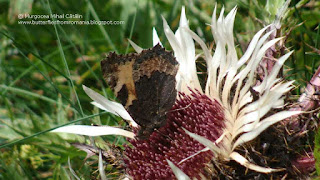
[163,7,301,173]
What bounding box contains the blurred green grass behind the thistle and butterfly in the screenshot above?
[0,0,320,179]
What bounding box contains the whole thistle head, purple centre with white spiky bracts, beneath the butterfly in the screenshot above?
[52,4,300,179]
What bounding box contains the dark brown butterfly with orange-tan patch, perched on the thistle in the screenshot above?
[101,44,178,139]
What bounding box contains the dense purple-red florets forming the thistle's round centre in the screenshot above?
[125,92,224,179]
